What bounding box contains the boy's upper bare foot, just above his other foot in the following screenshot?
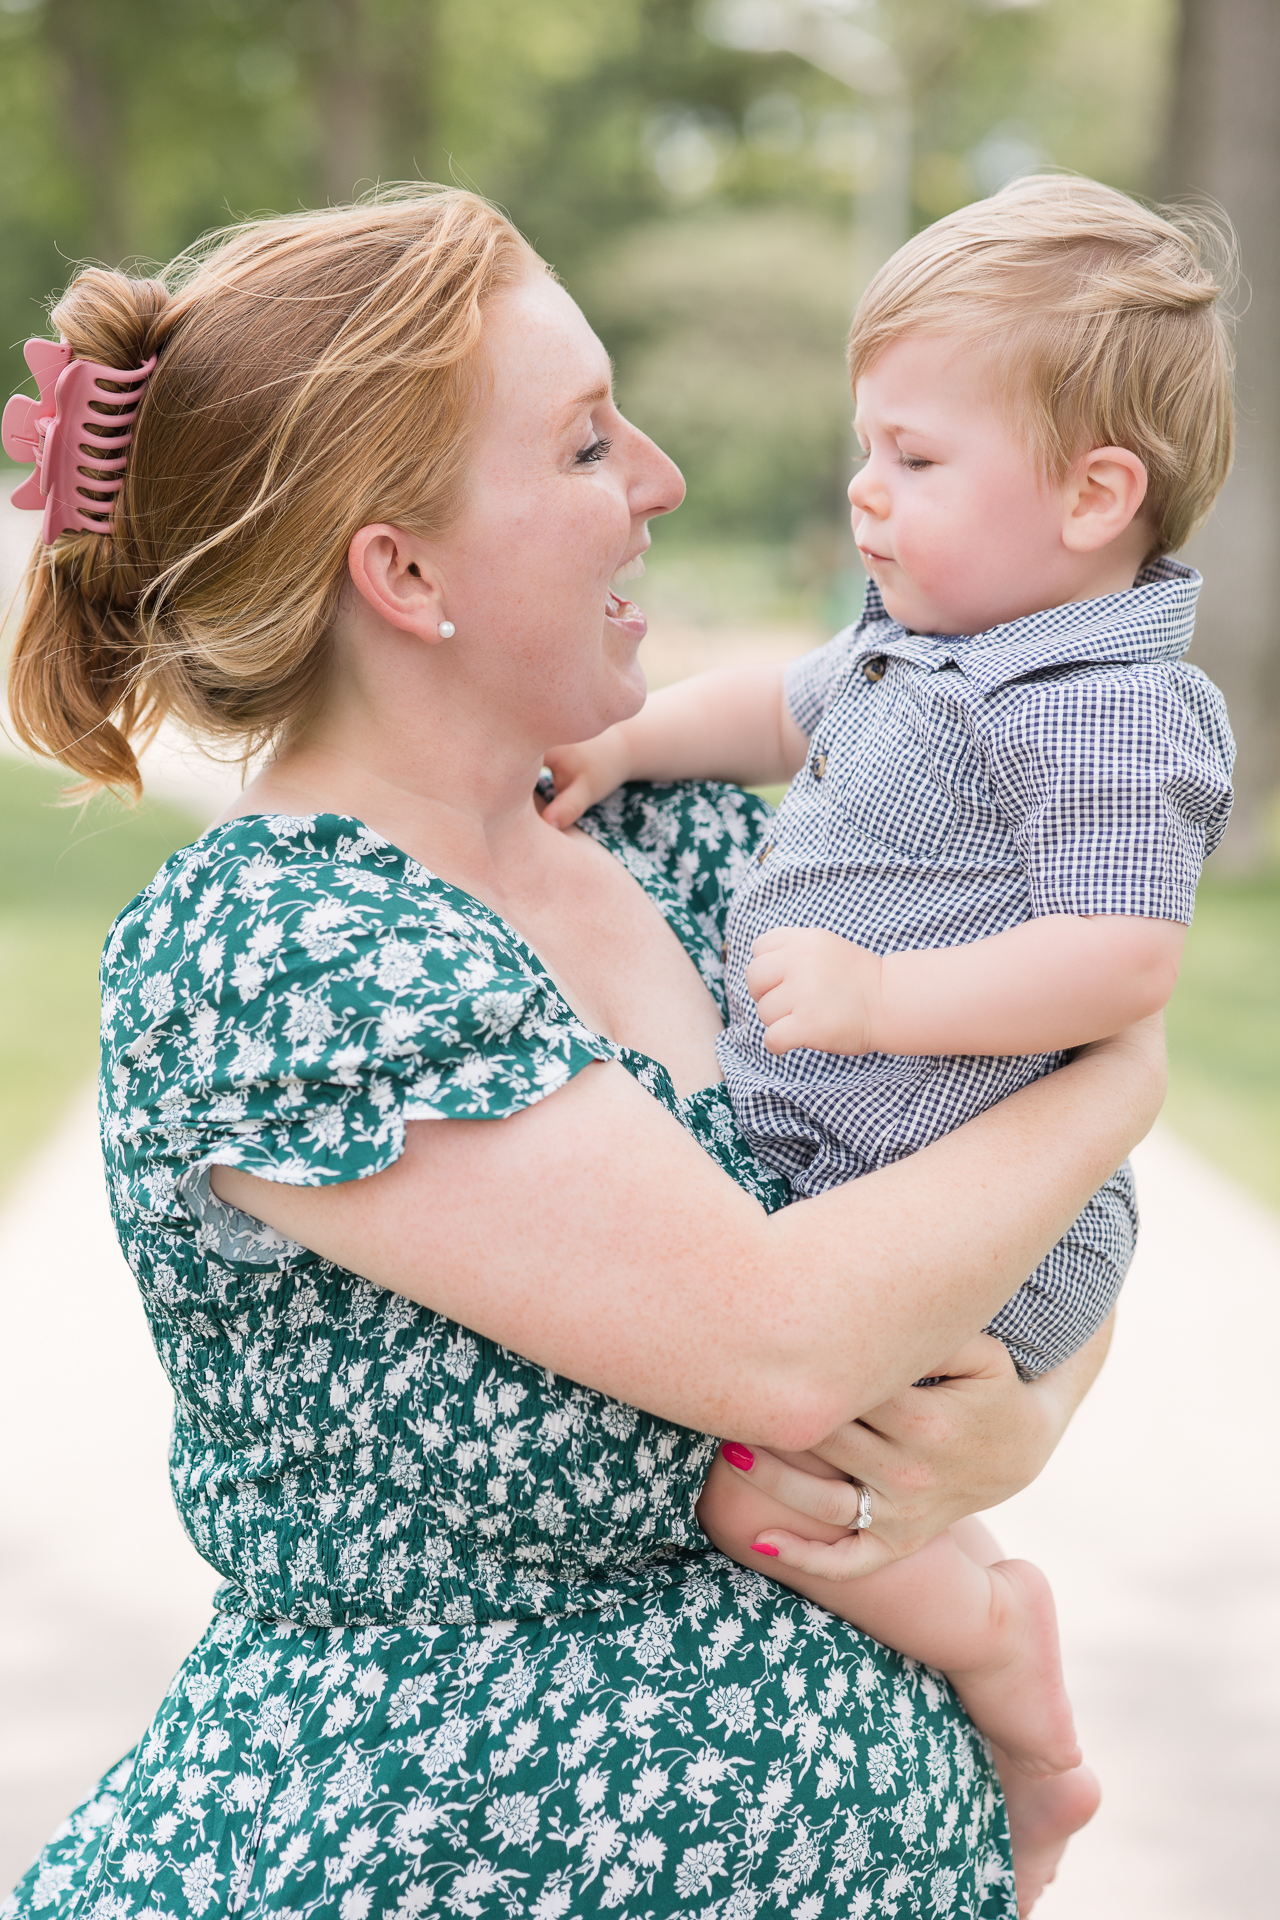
[946,1561,1088,1766]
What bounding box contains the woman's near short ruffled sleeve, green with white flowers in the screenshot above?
[104,816,608,1212]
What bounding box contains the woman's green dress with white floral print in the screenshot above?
[0,785,1015,1920]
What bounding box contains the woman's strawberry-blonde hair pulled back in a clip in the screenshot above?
[10,184,545,793]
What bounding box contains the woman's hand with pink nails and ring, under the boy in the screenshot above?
[699,1321,1111,1597]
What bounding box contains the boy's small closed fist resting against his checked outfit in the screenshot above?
[747,927,883,1054]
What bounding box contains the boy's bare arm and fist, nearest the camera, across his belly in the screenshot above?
[747,914,1186,1054]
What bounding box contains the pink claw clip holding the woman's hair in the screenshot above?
[0,340,155,547]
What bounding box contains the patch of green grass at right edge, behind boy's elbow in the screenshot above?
[1165,876,1280,1208]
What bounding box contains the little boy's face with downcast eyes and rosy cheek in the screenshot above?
[848,334,1109,634]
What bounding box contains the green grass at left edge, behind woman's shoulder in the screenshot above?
[0,760,200,1188]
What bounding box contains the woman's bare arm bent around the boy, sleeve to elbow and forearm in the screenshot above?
[213,1029,1163,1450]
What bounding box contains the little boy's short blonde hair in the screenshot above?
[848,175,1234,559]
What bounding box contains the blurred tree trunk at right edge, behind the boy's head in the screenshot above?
[1163,0,1280,870]
